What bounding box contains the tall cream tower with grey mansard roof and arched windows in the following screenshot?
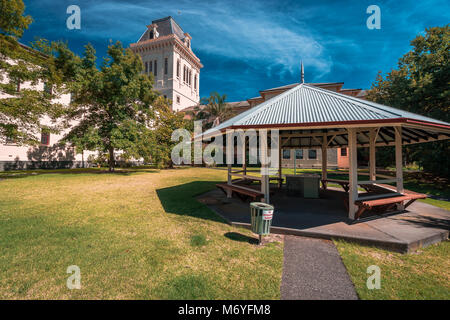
[130,16,203,111]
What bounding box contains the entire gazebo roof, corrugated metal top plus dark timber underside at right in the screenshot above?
[203,83,450,148]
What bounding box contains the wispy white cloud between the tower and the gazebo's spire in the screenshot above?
[178,3,332,75]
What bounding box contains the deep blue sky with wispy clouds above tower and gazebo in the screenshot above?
[22,0,450,101]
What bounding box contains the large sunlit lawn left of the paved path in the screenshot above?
[0,168,283,299]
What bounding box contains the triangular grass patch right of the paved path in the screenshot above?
[335,241,450,300]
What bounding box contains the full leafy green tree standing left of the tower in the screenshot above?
[65,42,157,171]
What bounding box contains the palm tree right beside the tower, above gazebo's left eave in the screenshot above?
[194,92,233,128]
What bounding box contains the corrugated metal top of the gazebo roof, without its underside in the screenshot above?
[204,83,450,142]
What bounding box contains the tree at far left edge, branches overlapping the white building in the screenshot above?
[0,0,65,144]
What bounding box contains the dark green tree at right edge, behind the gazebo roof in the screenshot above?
[367,25,450,177]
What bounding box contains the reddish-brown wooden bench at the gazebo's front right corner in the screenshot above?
[355,190,428,219]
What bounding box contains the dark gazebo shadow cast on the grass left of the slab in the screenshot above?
[156,181,226,223]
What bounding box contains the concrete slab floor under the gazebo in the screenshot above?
[197,190,450,253]
